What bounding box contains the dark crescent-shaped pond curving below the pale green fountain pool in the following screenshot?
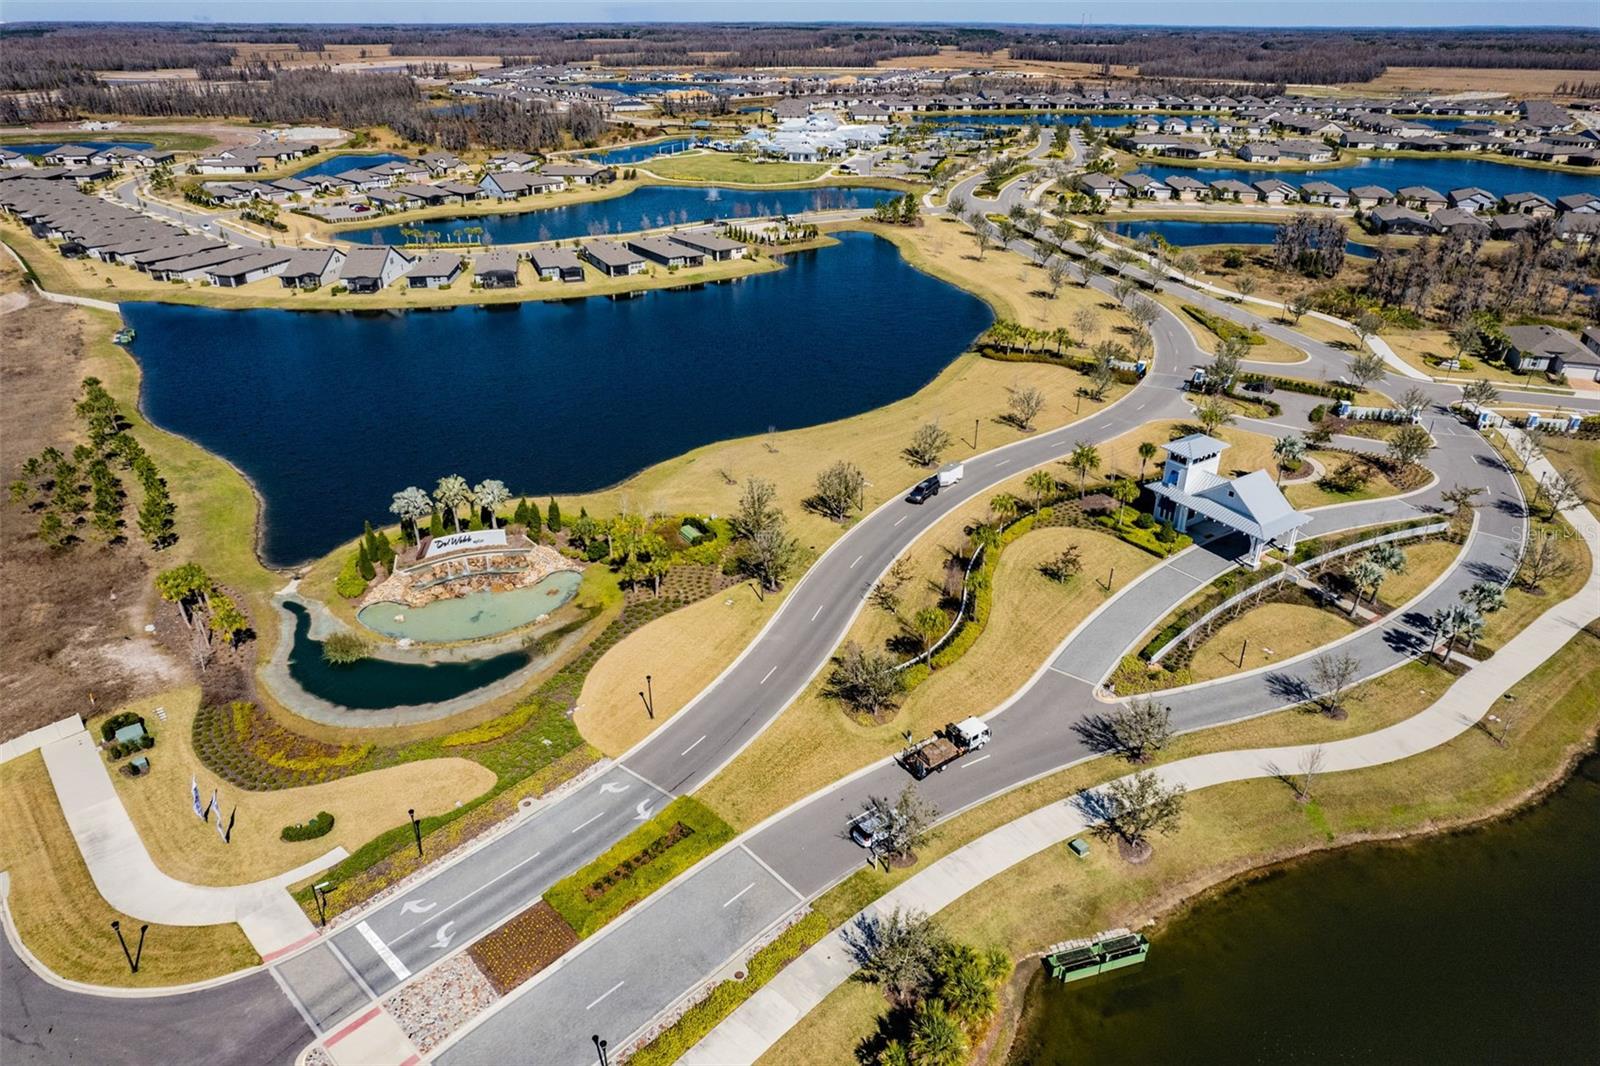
[283,602,530,711]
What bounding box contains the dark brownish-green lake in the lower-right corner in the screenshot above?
[1010,738,1600,1066]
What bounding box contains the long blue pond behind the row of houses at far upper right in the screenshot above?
[1139,157,1600,200]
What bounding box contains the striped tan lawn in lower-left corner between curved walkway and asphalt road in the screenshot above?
[0,752,256,988]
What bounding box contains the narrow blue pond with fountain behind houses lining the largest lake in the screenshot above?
[339,186,899,245]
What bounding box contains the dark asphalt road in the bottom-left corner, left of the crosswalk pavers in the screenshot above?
[0,936,312,1066]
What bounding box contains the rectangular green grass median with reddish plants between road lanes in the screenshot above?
[544,795,733,938]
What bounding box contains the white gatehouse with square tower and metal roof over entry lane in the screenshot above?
[1146,434,1312,568]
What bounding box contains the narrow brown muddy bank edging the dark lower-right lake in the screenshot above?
[973,715,1600,1066]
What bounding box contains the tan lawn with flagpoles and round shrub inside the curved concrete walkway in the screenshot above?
[112,687,494,885]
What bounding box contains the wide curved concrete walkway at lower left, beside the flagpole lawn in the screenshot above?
[40,728,347,959]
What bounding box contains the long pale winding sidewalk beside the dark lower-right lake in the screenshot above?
[682,428,1600,1066]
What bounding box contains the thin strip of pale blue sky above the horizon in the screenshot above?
[0,0,1600,27]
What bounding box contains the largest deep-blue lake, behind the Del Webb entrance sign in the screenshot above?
[123,234,990,565]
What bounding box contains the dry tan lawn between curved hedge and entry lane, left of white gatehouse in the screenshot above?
[699,527,1157,826]
